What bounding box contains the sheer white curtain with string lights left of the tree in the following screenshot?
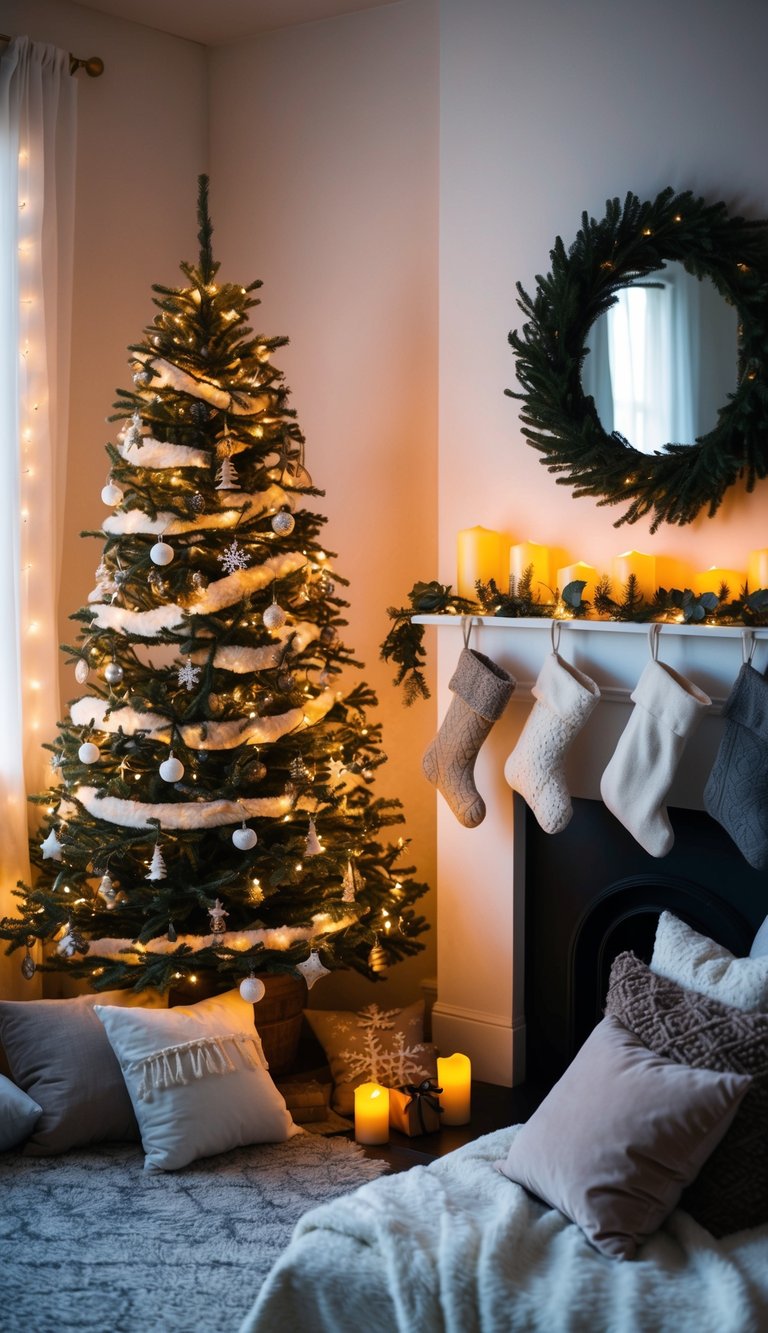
[0,37,77,998]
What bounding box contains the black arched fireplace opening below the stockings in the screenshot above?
[525,797,768,1086]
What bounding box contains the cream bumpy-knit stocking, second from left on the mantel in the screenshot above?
[504,652,600,833]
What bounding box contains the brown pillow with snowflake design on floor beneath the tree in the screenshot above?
[304,1001,437,1116]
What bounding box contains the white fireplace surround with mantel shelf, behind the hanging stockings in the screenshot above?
[413,615,768,1085]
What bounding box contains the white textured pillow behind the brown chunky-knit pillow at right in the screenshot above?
[651,912,768,1012]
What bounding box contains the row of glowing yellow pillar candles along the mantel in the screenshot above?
[456,527,768,601]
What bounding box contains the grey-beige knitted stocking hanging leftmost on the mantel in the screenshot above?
[423,648,515,829]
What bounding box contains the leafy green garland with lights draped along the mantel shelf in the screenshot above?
[380,565,768,708]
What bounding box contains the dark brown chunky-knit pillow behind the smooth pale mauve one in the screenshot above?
[607,953,768,1236]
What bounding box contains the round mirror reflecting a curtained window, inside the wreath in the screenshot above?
[583,263,737,453]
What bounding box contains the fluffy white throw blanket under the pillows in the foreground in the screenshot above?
[240,1128,768,1333]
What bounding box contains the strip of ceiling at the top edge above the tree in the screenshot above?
[72,0,395,47]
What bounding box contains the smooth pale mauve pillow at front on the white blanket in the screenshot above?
[490,1018,751,1258]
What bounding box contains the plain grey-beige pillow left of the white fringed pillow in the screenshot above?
[0,990,139,1157]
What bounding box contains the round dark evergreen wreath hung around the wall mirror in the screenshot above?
[505,187,768,532]
